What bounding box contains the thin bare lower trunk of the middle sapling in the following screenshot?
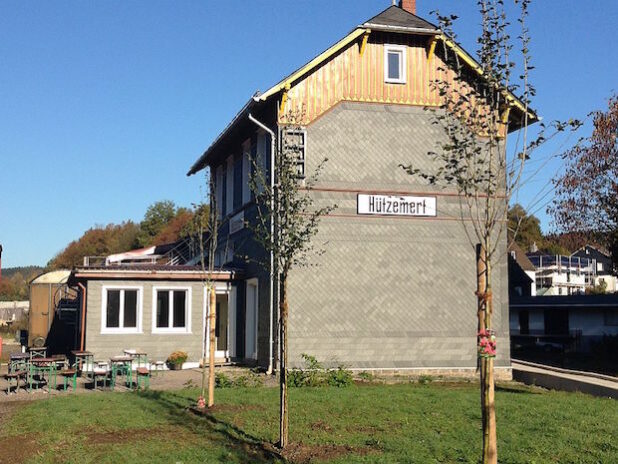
[279,275,288,449]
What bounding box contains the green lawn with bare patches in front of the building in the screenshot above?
[0,383,618,464]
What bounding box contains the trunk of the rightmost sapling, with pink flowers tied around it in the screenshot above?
[476,244,498,464]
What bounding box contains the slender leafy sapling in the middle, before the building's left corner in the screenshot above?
[249,110,335,449]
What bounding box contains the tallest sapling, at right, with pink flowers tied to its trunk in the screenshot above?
[401,0,579,463]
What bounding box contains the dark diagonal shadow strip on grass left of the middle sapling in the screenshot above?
[138,390,285,463]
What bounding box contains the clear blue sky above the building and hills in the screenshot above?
[0,0,618,267]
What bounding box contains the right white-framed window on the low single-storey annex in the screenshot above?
[152,287,191,333]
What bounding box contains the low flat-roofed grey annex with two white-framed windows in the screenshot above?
[68,262,239,367]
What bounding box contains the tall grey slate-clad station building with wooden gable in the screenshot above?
[188,1,534,370]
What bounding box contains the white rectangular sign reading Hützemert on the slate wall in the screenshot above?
[357,193,437,217]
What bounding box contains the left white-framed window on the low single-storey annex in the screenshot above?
[101,285,142,334]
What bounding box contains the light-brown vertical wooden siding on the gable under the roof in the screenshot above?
[279,32,444,125]
